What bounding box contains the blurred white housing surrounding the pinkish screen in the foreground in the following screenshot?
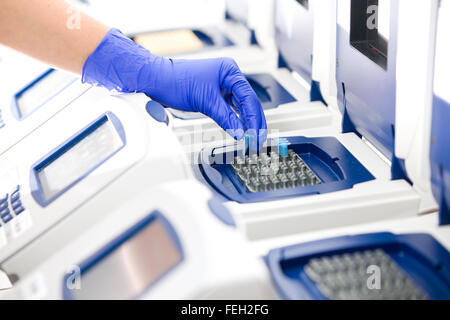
[0,181,275,299]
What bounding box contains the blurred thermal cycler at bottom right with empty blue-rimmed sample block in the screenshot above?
[264,9,450,300]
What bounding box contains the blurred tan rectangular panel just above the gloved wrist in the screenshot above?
[134,30,204,55]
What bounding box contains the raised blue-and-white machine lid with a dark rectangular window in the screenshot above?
[336,0,405,162]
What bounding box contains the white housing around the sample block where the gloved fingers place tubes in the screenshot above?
[187,0,438,240]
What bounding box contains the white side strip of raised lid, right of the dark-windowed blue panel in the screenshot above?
[395,0,438,213]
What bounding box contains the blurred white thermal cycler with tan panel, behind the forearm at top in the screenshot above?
[72,0,271,69]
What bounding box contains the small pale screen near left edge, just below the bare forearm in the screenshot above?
[16,70,77,119]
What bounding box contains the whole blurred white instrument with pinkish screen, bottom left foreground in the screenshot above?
[0,181,275,299]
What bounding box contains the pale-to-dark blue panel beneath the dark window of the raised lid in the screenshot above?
[336,0,398,160]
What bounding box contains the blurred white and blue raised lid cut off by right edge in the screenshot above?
[430,2,450,225]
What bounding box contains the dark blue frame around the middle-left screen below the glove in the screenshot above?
[30,112,126,207]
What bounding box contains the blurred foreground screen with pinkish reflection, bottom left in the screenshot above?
[72,219,182,300]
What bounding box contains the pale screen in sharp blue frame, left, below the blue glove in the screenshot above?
[34,115,124,201]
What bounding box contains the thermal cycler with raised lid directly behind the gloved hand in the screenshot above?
[149,0,335,152]
